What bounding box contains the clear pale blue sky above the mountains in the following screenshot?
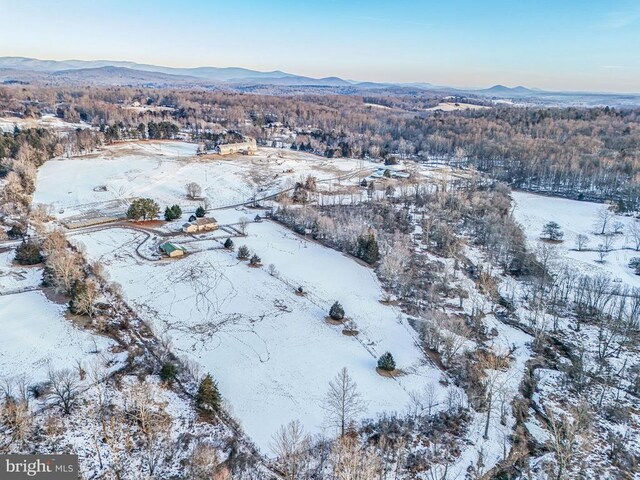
[0,0,640,92]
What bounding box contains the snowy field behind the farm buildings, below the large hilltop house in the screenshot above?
[34,141,375,217]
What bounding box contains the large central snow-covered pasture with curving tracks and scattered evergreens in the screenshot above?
[75,222,453,453]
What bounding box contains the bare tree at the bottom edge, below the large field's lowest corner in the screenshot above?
[271,420,311,480]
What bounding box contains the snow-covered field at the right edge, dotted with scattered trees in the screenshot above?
[512,192,640,287]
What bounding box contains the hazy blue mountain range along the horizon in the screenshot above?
[0,57,640,105]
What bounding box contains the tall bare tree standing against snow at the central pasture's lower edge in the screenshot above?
[325,367,365,436]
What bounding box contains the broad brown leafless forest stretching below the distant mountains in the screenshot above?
[0,87,640,210]
